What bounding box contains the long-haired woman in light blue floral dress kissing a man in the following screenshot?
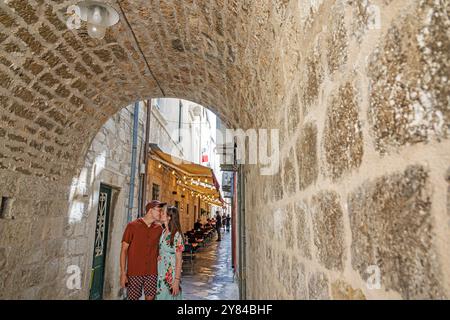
[156,207,184,300]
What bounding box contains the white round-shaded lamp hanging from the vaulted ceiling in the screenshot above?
[77,0,119,39]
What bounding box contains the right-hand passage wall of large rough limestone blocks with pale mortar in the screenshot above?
[245,0,450,299]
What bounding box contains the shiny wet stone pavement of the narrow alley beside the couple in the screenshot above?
[182,231,239,300]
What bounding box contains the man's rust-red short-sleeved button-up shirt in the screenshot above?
[122,218,163,276]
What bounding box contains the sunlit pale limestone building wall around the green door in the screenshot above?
[67,102,146,299]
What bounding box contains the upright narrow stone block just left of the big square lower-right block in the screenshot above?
[311,191,345,271]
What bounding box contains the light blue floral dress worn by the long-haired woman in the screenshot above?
[156,232,184,300]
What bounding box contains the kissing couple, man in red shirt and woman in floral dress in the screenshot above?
[120,200,184,300]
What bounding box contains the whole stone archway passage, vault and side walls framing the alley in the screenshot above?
[0,0,450,298]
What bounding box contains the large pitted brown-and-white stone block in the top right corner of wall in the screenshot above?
[368,1,450,154]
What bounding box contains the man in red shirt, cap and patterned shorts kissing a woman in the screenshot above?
[120,200,166,300]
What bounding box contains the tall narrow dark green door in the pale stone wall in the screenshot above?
[89,185,112,300]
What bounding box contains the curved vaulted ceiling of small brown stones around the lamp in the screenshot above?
[0,0,287,178]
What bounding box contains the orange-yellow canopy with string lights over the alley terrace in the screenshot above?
[149,143,224,206]
